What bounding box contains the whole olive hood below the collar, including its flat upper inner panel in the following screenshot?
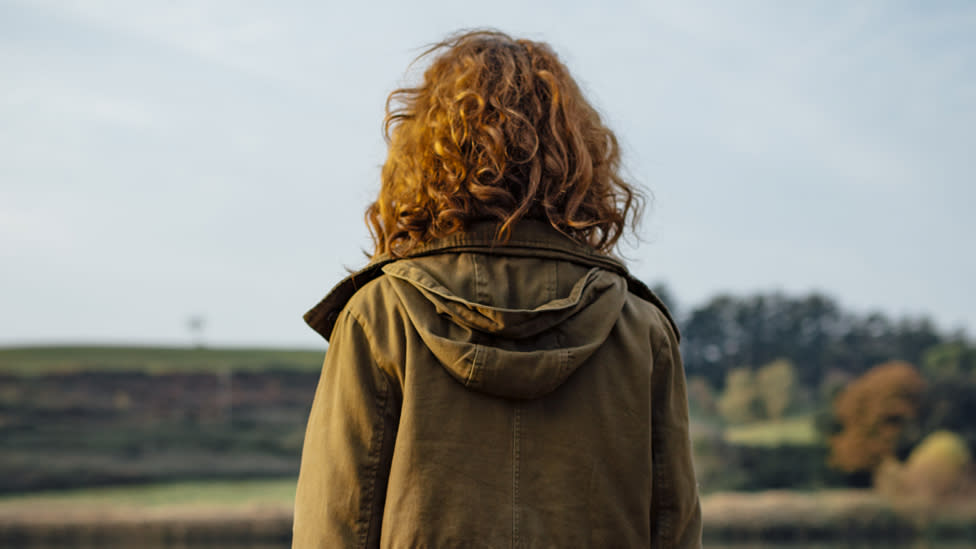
[383,254,627,399]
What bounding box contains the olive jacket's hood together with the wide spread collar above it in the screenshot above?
[305,220,680,399]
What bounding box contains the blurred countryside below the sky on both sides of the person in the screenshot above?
[0,285,976,545]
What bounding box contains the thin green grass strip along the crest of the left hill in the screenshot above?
[0,346,325,376]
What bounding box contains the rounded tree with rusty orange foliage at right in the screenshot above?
[830,361,925,472]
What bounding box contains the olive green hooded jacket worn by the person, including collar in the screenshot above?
[293,221,701,549]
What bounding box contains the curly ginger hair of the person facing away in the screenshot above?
[366,30,644,257]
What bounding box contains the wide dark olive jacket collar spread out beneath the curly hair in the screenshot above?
[304,220,680,340]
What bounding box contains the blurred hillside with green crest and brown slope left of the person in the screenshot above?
[0,347,324,493]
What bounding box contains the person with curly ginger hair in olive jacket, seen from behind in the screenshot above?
[293,31,702,549]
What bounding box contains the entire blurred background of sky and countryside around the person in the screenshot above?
[0,0,976,549]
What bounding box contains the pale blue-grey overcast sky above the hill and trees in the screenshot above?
[0,0,976,347]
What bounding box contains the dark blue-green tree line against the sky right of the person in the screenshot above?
[655,285,976,390]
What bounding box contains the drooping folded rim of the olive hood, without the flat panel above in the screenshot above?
[383,260,627,399]
